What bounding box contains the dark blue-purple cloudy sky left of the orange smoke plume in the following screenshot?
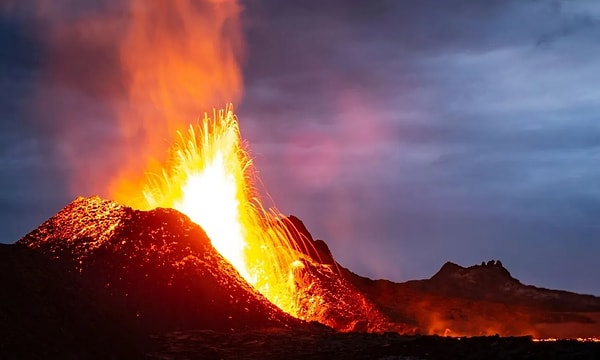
[0,2,118,242]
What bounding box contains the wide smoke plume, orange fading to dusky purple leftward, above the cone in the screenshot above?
[5,0,243,202]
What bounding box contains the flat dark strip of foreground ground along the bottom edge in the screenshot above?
[146,329,600,360]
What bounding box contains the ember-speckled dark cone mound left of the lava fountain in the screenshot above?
[18,197,300,332]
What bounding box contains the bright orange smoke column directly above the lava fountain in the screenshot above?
[109,0,243,205]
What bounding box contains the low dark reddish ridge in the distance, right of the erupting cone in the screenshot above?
[344,261,600,338]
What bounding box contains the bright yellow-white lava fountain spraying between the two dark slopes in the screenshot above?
[144,106,302,315]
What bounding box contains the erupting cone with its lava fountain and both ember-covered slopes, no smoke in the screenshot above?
[15,102,394,331]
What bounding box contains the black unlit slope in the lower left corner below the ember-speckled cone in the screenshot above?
[0,244,145,359]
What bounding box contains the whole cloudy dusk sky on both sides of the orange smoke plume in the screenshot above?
[0,0,600,295]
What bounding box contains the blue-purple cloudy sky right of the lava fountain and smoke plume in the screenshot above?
[239,1,600,293]
